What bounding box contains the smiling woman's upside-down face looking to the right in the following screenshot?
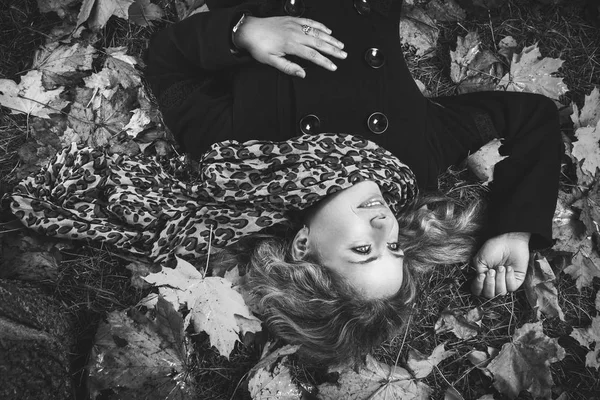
[296,181,404,298]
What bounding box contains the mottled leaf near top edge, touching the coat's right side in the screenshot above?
[400,6,439,56]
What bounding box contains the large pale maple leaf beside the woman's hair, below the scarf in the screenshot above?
[143,258,261,357]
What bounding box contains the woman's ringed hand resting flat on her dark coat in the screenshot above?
[233,16,347,78]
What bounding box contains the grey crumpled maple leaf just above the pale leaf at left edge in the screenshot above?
[32,42,96,87]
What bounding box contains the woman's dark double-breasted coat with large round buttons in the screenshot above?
[146,0,561,247]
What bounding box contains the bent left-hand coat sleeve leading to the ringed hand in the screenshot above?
[146,1,252,157]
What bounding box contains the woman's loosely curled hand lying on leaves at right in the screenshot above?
[471,232,531,299]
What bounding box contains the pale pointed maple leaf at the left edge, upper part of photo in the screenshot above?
[0,70,68,118]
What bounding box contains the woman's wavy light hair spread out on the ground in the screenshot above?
[211,197,479,365]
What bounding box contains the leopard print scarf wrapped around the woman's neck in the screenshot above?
[10,134,417,262]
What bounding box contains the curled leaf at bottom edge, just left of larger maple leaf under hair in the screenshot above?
[248,345,303,400]
